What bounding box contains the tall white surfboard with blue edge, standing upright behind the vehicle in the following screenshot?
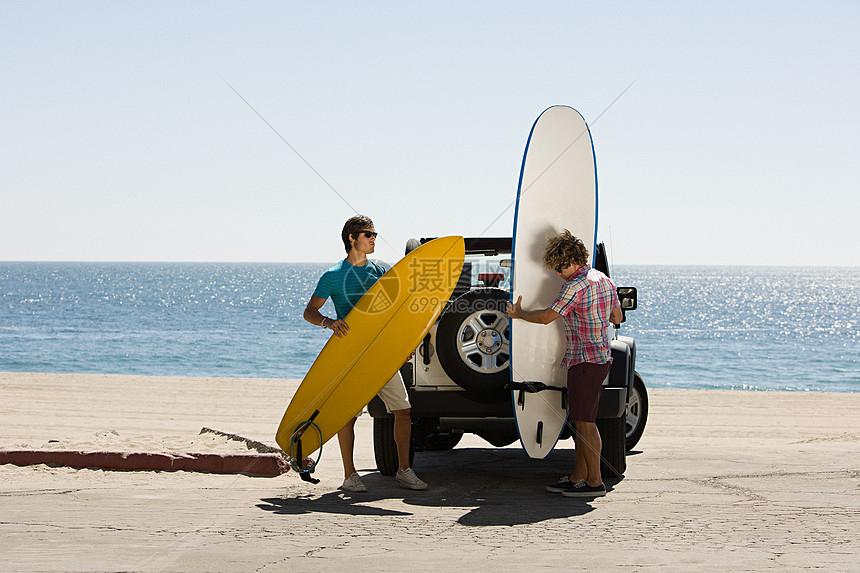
[511,106,597,458]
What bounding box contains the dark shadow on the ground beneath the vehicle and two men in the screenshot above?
[258,448,612,526]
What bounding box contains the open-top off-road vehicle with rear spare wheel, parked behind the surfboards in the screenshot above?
[368,238,648,477]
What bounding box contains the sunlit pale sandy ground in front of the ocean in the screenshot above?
[0,373,860,571]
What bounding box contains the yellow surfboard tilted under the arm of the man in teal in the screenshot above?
[275,237,465,456]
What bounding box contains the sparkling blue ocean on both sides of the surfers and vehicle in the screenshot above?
[0,262,860,392]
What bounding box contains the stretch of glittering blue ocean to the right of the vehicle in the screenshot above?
[613,266,860,392]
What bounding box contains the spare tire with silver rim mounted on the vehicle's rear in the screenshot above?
[436,289,511,403]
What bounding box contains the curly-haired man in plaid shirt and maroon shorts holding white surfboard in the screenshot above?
[508,230,623,497]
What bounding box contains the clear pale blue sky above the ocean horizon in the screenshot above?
[0,0,860,266]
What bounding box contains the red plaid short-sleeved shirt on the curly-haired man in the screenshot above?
[550,265,620,370]
